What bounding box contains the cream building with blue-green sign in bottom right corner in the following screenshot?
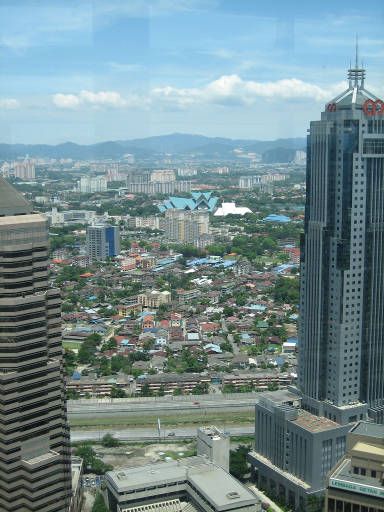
[326,422,384,512]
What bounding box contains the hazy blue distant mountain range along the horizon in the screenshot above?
[0,133,306,163]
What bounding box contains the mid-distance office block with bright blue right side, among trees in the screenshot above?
[87,224,120,261]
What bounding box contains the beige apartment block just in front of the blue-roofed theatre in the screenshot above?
[164,210,209,245]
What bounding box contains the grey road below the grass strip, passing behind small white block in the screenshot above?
[71,426,254,442]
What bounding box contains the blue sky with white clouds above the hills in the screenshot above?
[0,0,384,144]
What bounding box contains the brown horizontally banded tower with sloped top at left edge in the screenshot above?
[0,178,71,512]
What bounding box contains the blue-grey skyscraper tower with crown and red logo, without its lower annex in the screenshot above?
[299,58,384,423]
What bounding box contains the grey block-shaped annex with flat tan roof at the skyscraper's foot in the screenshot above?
[248,397,350,506]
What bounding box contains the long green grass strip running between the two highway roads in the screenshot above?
[69,411,255,428]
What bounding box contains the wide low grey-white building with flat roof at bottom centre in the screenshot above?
[105,456,261,512]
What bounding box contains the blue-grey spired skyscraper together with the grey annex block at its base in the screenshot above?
[250,62,384,510]
